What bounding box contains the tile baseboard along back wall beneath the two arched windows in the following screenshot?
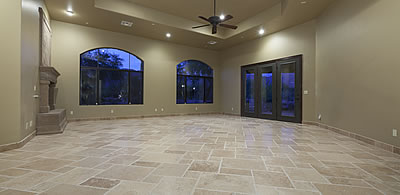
[67,112,222,122]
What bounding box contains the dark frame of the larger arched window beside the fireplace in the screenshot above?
[79,47,144,106]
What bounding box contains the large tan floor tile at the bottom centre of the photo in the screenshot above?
[197,174,255,194]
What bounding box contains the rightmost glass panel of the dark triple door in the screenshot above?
[280,63,296,117]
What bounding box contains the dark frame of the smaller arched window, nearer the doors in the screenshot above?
[175,60,214,105]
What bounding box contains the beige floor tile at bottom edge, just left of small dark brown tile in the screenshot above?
[40,184,107,195]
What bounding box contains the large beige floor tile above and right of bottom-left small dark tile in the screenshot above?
[96,165,153,181]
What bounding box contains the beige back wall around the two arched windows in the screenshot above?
[52,21,220,119]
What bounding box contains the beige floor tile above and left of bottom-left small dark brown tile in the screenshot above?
[52,168,100,185]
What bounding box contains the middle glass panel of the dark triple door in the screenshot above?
[261,67,273,114]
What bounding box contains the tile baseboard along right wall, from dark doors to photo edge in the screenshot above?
[303,121,400,155]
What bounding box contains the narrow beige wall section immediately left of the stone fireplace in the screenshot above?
[20,0,46,139]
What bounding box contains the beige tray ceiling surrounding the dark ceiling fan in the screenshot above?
[45,0,335,50]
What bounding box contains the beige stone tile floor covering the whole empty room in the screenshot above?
[0,115,400,195]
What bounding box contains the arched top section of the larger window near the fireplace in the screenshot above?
[81,48,143,71]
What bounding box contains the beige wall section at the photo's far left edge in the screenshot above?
[0,0,21,145]
